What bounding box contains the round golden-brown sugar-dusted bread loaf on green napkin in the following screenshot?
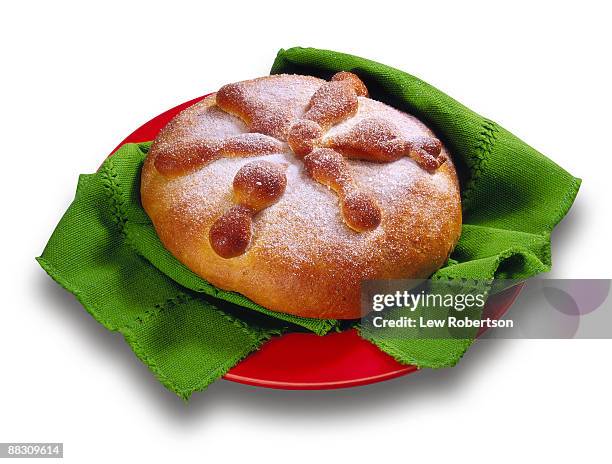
[141,72,461,319]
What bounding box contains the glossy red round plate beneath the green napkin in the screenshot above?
[113,97,521,390]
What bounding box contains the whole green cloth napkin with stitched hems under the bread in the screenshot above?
[37,48,580,398]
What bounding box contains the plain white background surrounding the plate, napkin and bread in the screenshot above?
[0,0,612,463]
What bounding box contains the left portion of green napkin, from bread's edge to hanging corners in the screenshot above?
[37,143,335,398]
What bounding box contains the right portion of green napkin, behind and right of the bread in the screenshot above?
[271,48,581,367]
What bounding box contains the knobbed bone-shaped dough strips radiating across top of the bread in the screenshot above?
[155,71,446,258]
